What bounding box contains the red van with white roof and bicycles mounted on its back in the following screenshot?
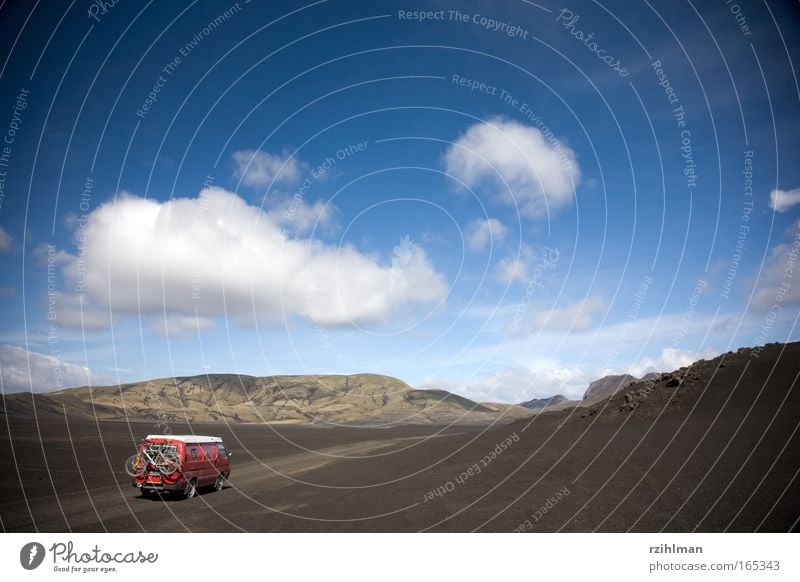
[125,434,231,498]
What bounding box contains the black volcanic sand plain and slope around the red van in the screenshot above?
[0,344,800,532]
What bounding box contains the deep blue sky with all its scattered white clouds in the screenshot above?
[0,0,800,402]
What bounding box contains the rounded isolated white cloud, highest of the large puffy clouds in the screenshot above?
[445,117,580,218]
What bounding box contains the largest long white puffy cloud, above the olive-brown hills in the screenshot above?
[57,188,447,333]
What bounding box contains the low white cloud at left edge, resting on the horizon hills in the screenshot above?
[0,345,94,394]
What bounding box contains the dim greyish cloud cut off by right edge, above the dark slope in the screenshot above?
[751,219,800,311]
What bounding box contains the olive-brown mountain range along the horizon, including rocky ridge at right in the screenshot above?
[0,348,792,425]
